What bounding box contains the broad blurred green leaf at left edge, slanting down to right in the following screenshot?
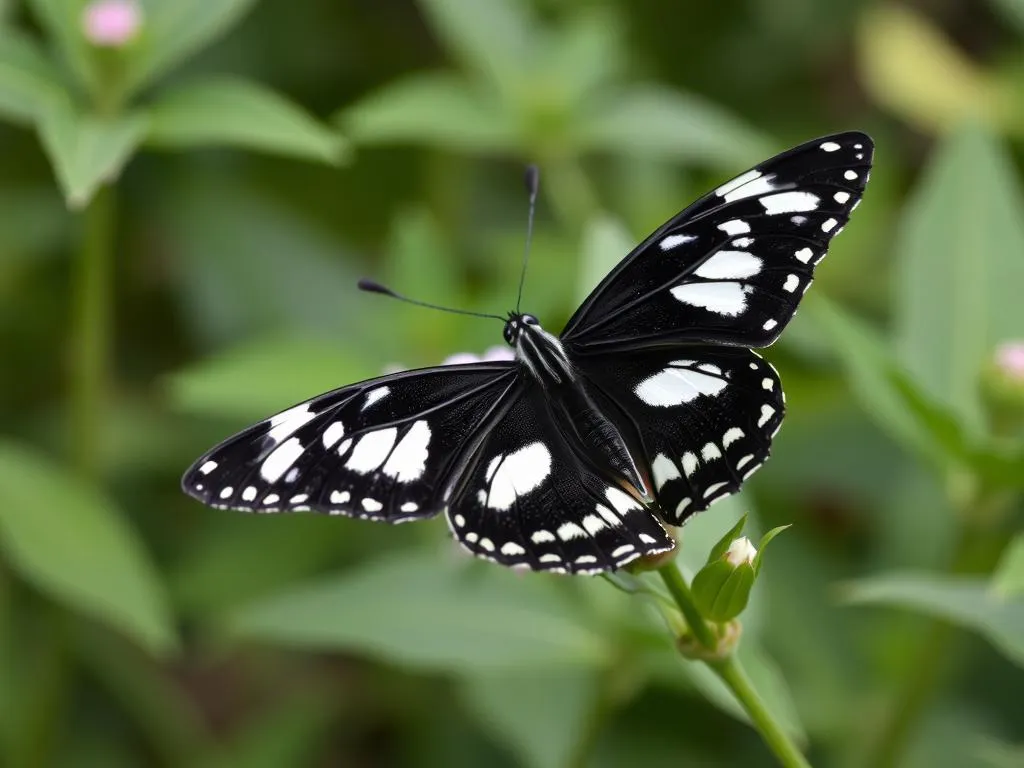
[0,442,176,653]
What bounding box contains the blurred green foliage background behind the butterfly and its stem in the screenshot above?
[0,0,1024,768]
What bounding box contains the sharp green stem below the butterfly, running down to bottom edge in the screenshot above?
[658,562,810,768]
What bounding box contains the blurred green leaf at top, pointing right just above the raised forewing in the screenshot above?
[578,85,772,166]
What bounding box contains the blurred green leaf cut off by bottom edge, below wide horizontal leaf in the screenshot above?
[462,670,598,768]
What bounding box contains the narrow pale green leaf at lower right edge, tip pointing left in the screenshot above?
[843,573,1024,667]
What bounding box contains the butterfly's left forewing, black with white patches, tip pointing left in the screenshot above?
[181,362,516,522]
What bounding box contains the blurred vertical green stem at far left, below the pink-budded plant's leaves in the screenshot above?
[71,185,115,479]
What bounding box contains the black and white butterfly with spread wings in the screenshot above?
[182,132,872,573]
